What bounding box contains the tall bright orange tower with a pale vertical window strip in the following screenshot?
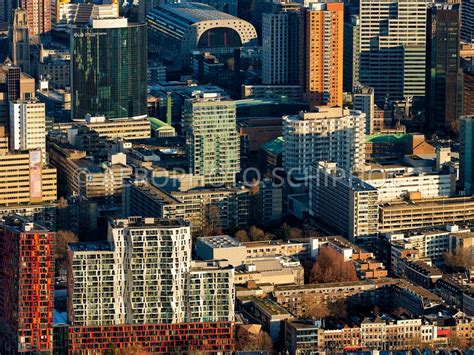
[300,3,344,109]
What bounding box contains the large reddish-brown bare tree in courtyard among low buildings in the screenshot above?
[309,247,359,283]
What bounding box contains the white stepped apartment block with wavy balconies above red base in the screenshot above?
[68,217,235,325]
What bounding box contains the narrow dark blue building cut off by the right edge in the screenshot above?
[459,116,474,195]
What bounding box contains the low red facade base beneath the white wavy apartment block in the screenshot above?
[68,322,235,355]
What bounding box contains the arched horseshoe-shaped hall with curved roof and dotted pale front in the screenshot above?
[147,2,257,66]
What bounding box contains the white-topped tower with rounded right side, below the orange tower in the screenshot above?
[283,107,365,175]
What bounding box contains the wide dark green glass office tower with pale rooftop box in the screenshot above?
[71,18,147,120]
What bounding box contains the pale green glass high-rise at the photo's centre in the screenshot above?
[183,94,240,186]
